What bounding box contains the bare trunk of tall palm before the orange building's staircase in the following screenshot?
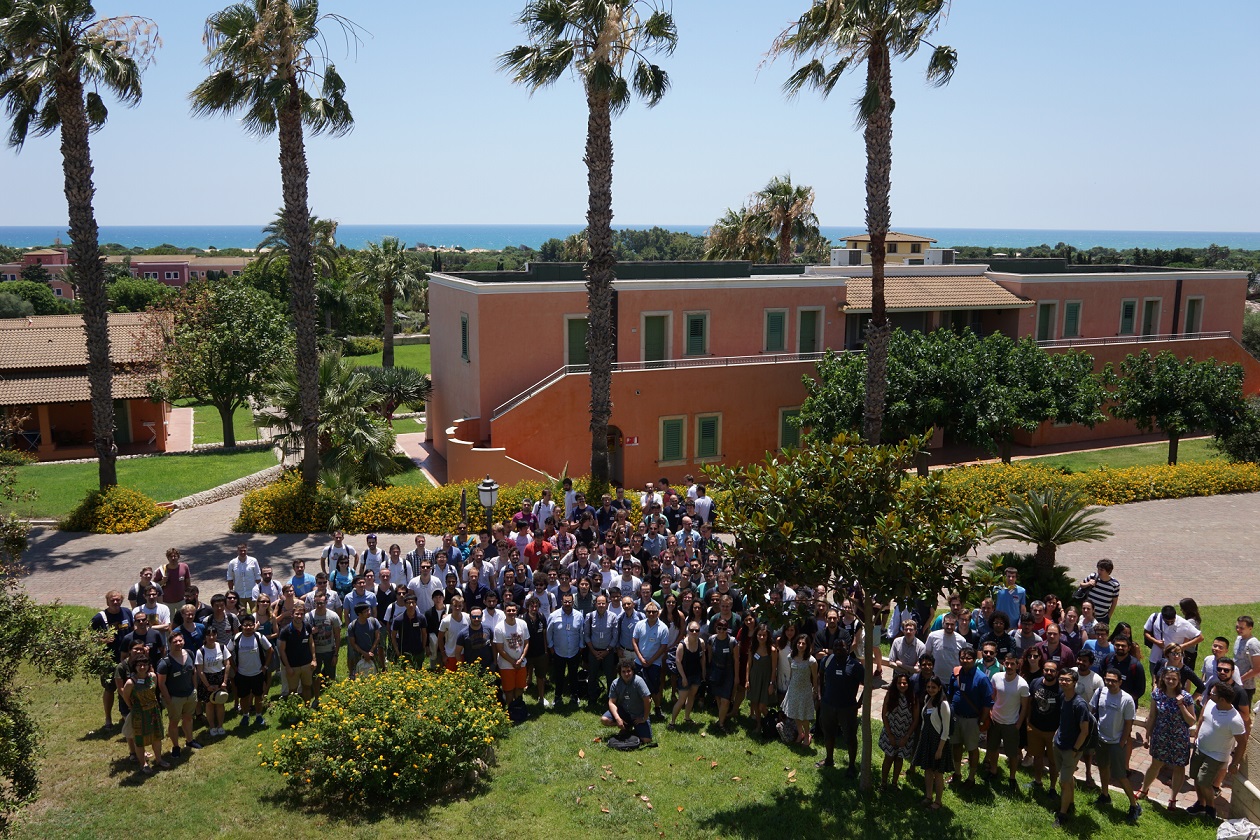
[586,87,616,494]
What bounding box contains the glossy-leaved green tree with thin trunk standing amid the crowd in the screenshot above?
[709,434,980,788]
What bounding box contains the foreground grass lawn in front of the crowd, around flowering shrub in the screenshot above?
[14,607,1239,840]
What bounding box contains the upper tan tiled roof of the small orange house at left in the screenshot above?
[0,312,156,372]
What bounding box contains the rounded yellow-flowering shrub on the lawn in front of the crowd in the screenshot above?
[258,666,509,802]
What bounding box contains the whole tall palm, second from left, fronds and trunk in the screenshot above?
[190,0,354,485]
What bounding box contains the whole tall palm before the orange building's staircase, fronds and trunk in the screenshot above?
[499,0,678,487]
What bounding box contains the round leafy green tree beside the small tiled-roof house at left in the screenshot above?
[147,281,291,447]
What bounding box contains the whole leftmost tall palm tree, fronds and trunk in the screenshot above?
[0,0,161,490]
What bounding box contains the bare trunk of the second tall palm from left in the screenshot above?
[278,85,319,486]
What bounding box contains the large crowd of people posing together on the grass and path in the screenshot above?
[83,476,1260,824]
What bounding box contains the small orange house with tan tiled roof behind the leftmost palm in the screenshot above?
[0,314,170,461]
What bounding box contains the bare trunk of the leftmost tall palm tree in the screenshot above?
[57,72,118,490]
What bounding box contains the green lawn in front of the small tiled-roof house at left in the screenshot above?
[4,450,276,518]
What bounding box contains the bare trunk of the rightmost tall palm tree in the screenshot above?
[862,37,892,446]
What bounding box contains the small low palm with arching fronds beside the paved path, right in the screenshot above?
[992,487,1111,572]
